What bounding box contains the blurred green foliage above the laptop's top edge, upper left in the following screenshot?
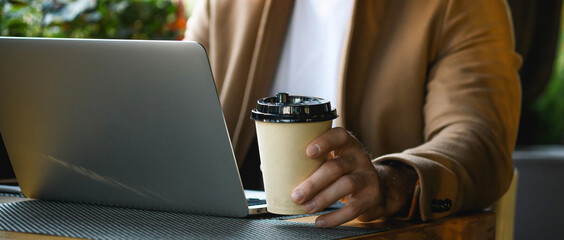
[0,0,186,39]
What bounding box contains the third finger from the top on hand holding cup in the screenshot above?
[303,173,366,213]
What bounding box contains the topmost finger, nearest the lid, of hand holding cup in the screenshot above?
[306,127,360,158]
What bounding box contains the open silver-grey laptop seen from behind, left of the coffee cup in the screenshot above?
[0,37,266,217]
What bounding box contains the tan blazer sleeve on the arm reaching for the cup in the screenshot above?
[373,0,521,221]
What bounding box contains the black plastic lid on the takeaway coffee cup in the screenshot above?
[251,93,338,123]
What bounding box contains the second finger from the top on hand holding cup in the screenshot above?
[291,156,355,204]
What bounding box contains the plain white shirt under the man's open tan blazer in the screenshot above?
[271,0,354,110]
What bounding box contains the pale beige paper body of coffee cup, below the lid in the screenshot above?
[255,120,332,215]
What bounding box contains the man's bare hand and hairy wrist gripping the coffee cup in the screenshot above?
[291,128,417,227]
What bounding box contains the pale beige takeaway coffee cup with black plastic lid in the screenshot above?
[251,93,337,215]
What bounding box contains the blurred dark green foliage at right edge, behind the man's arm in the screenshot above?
[534,9,564,144]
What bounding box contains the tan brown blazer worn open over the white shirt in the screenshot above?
[187,0,521,220]
